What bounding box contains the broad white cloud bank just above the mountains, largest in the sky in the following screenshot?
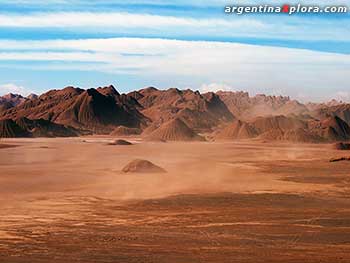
[0,38,350,100]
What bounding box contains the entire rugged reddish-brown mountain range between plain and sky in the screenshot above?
[0,86,350,143]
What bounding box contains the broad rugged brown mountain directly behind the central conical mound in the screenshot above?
[128,87,234,131]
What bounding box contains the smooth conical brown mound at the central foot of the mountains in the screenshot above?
[147,118,204,141]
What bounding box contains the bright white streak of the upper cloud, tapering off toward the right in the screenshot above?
[0,12,264,29]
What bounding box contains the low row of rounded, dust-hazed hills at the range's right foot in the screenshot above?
[213,115,350,143]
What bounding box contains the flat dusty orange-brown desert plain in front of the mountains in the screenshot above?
[0,137,350,262]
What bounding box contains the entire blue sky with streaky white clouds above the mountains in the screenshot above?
[0,0,350,102]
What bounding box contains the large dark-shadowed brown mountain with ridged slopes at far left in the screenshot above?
[0,86,146,133]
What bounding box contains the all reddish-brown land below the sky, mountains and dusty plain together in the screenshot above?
[0,86,350,263]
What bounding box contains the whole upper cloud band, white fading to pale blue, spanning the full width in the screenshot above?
[0,10,350,41]
